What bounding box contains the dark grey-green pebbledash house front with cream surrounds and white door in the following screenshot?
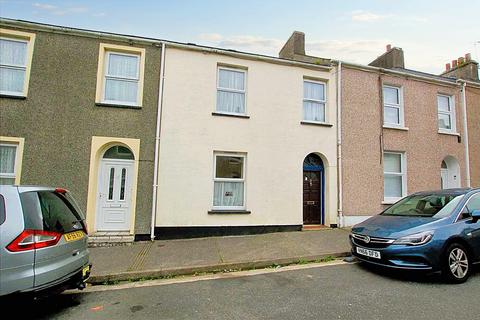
[0,19,161,241]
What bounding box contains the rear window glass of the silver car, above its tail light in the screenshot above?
[20,191,83,233]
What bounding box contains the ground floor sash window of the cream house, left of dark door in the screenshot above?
[213,153,245,210]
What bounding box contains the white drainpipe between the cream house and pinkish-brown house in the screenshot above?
[337,61,345,227]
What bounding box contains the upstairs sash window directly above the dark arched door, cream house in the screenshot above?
[303,80,326,122]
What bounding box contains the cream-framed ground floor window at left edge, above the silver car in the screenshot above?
[0,138,23,184]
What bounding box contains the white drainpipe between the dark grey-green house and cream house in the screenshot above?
[150,42,166,241]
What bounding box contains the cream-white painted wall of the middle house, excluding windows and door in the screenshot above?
[156,48,337,226]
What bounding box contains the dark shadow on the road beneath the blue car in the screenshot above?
[357,262,480,285]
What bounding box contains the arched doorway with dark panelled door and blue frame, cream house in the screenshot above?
[303,153,325,225]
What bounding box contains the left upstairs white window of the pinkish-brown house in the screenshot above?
[383,86,404,127]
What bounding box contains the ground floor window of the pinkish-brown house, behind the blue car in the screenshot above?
[383,152,407,202]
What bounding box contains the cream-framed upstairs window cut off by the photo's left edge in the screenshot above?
[0,29,35,97]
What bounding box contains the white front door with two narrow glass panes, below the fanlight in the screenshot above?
[96,159,134,231]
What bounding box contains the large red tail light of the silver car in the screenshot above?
[7,229,62,252]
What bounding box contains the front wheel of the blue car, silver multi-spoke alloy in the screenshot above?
[443,243,472,283]
